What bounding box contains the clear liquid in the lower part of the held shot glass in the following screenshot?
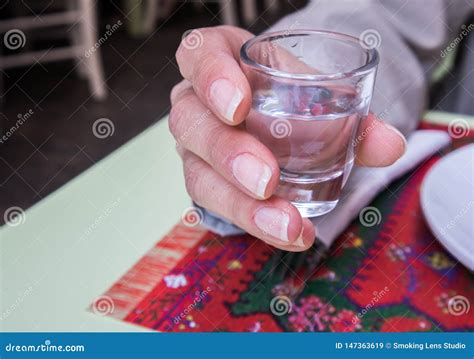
[246,85,368,217]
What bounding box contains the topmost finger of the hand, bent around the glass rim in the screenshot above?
[176,26,253,125]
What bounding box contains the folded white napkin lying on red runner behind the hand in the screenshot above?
[202,130,451,247]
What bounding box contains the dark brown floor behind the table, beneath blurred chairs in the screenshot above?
[0,0,306,223]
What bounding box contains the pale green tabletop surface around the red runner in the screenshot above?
[0,112,474,331]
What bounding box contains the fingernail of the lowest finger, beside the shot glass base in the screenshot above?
[254,207,290,242]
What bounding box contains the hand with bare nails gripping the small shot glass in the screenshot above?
[169,26,406,251]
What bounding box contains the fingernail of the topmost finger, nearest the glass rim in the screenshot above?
[210,79,244,122]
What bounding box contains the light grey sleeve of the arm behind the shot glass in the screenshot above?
[199,0,474,235]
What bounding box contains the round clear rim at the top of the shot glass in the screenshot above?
[240,29,379,81]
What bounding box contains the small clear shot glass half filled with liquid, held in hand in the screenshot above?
[240,30,378,217]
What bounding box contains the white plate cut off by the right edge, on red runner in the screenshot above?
[421,144,474,271]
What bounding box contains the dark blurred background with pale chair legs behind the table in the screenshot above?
[0,0,474,223]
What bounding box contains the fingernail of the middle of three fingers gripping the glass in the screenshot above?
[232,153,272,198]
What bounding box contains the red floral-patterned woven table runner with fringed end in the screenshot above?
[90,122,474,332]
